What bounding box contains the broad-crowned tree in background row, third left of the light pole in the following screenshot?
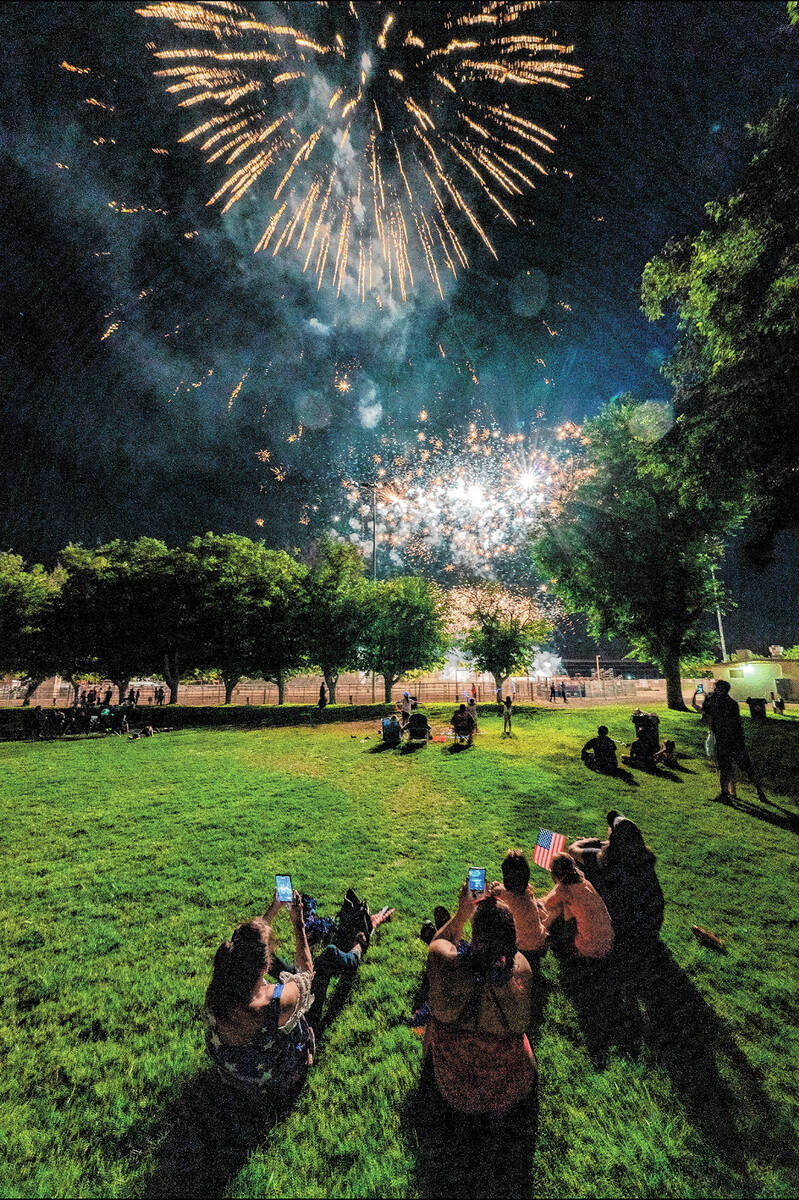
[184,533,289,704]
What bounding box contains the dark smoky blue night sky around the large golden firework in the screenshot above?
[0,0,799,650]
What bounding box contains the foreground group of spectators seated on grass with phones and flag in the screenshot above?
[204,811,663,1114]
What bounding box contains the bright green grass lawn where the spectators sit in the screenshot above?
[0,708,799,1198]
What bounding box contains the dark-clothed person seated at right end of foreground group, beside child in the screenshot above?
[569,809,663,953]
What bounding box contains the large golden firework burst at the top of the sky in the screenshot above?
[137,0,581,301]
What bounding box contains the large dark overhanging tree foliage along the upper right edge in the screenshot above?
[642,97,799,565]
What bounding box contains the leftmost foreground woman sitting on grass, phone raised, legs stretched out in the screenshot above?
[204,892,394,1108]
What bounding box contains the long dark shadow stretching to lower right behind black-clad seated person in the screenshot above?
[560,942,799,1195]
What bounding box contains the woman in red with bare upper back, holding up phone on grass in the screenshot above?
[425,882,536,1115]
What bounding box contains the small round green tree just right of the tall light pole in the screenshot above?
[359,575,449,703]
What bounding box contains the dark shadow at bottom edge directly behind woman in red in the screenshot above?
[403,1057,539,1198]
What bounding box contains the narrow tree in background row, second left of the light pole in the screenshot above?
[253,550,308,704]
